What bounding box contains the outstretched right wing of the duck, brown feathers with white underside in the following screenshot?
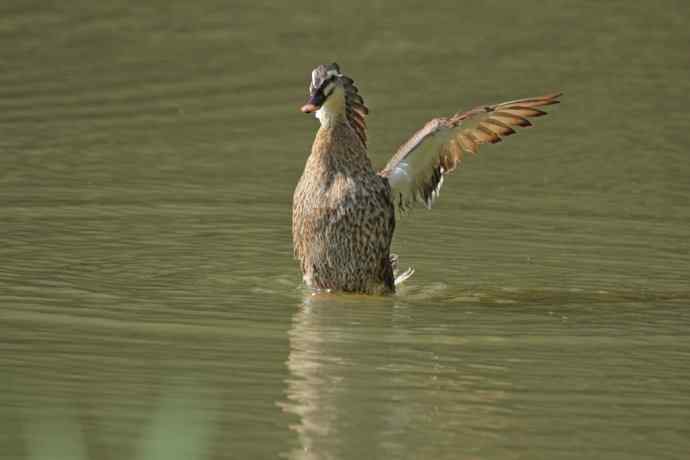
[379,93,561,212]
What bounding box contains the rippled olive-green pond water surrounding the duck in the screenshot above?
[0,1,690,460]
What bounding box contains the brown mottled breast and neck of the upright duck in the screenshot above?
[292,63,395,294]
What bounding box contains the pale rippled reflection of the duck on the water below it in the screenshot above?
[283,296,511,459]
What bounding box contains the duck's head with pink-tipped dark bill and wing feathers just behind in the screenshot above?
[301,62,369,144]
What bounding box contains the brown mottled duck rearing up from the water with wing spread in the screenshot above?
[292,63,562,295]
